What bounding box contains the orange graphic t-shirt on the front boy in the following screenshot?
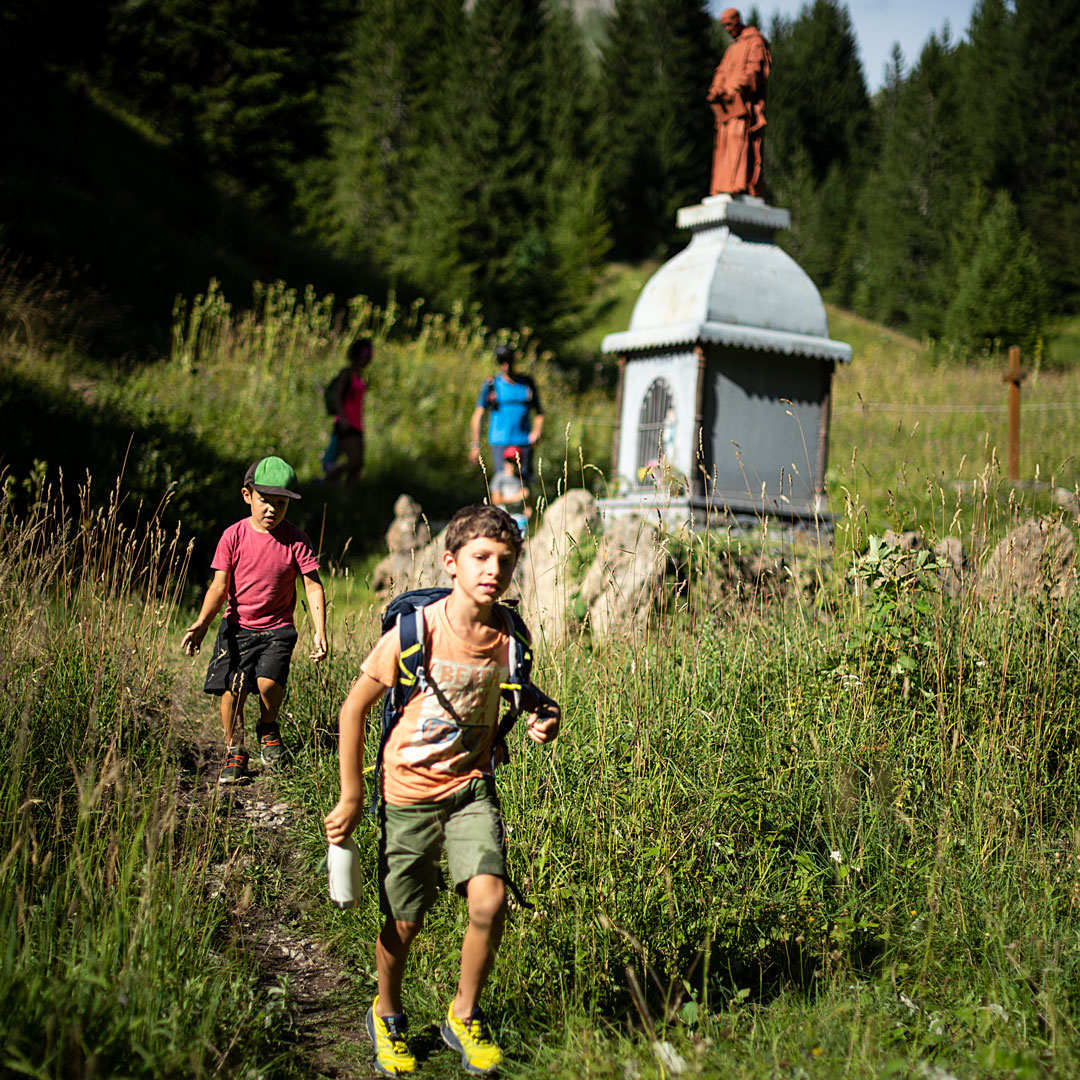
[361,598,510,806]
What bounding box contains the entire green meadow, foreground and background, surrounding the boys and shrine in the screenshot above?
[0,278,1080,1080]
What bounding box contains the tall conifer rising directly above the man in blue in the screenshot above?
[402,0,600,327]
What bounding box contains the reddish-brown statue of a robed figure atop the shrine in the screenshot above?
[706,8,772,195]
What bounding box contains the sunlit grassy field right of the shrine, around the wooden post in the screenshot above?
[827,310,1080,531]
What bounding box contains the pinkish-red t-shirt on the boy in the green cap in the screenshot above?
[211,517,319,630]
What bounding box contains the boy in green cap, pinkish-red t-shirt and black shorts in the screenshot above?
[180,457,326,784]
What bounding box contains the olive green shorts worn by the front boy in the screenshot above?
[379,777,507,922]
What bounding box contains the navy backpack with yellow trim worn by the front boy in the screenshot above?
[372,586,535,813]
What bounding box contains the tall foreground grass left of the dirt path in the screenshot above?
[0,485,295,1078]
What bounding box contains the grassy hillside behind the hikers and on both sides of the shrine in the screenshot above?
[8,264,1080,583]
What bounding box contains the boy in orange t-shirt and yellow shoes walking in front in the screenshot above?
[325,507,562,1076]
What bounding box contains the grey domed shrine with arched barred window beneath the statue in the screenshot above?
[603,194,851,531]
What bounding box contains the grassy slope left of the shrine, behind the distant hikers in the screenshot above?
[0,273,613,583]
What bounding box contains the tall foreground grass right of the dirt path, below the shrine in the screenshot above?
[261,466,1080,1077]
